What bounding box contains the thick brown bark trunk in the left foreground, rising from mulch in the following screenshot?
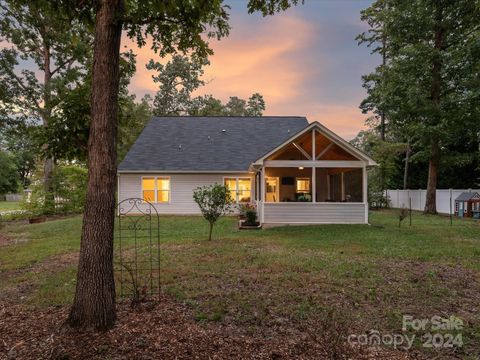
[68,0,123,329]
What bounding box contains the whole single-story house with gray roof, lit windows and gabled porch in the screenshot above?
[118,116,376,225]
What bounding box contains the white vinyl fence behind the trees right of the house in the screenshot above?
[385,189,480,214]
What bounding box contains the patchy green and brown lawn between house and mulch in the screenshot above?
[0,211,480,356]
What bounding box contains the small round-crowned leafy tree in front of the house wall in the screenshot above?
[193,184,232,240]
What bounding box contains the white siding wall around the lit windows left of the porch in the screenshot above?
[118,173,254,215]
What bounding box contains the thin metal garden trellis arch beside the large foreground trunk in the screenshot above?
[114,198,160,301]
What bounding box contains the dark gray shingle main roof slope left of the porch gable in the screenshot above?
[118,116,308,172]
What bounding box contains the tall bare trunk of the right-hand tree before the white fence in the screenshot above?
[423,2,445,214]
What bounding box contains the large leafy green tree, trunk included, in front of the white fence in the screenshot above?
[365,0,480,213]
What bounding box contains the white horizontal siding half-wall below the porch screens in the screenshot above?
[263,202,367,224]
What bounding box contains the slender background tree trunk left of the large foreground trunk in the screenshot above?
[42,40,55,213]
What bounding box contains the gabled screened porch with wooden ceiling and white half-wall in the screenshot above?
[253,124,371,225]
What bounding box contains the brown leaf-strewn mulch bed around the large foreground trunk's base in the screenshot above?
[0,296,409,360]
